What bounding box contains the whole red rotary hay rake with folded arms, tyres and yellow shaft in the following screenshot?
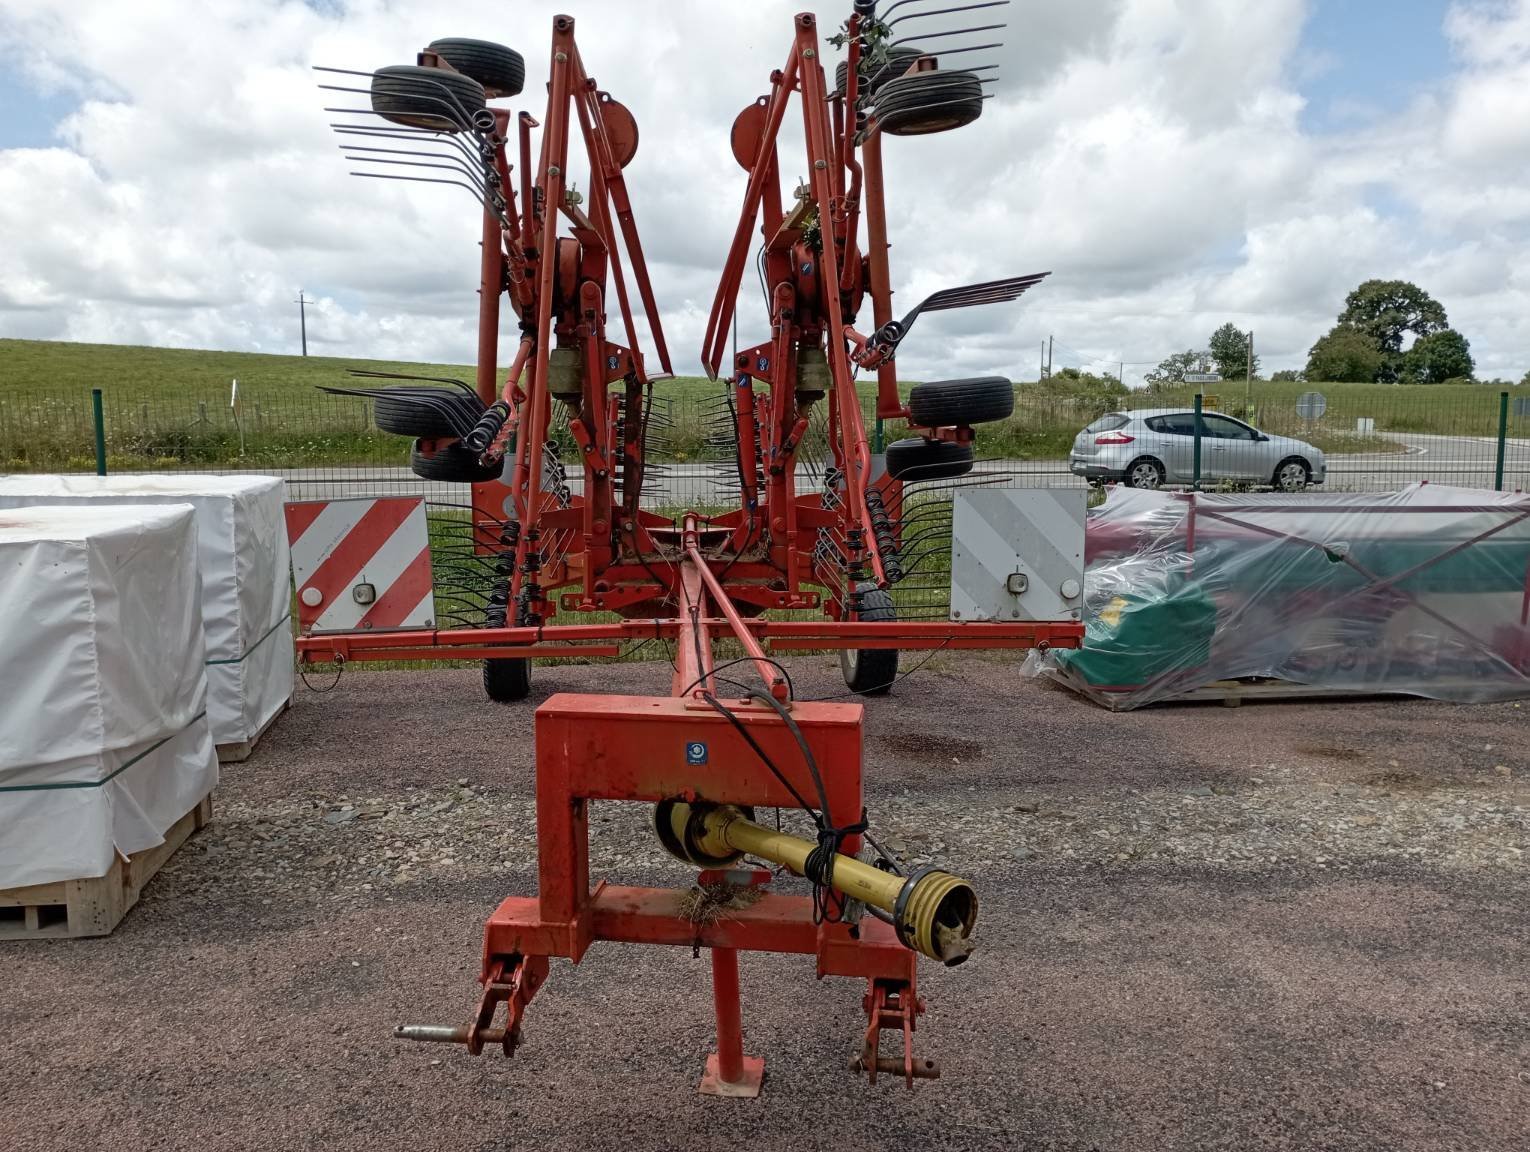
[298,0,1082,1095]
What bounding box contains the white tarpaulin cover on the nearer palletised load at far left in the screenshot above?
[0,503,217,887]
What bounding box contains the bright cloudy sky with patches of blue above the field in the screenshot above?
[0,0,1530,384]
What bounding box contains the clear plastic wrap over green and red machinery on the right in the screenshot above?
[1027,483,1530,710]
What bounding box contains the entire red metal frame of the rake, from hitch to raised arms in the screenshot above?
[328,14,1083,1095]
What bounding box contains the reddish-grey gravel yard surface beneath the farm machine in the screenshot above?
[0,658,1530,1152]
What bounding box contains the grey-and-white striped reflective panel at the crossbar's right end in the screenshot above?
[952,488,1088,621]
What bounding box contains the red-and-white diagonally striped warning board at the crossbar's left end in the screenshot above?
[286,496,436,632]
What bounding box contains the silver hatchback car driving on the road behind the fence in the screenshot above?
[1068,408,1328,493]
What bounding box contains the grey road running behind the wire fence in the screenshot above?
[232,433,1530,506]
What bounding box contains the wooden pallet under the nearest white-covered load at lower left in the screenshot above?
[0,796,213,941]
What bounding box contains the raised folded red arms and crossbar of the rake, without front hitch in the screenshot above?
[298,12,1083,661]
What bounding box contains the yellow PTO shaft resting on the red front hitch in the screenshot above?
[655,800,978,965]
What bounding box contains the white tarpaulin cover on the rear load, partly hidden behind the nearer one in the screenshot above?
[0,474,292,744]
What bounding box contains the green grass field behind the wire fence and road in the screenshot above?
[0,340,1524,471]
